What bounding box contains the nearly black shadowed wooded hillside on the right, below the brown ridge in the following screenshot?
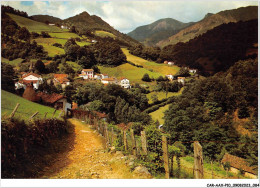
[160,19,258,75]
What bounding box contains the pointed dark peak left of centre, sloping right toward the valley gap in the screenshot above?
[62,11,140,45]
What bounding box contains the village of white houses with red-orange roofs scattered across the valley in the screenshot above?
[12,61,199,117]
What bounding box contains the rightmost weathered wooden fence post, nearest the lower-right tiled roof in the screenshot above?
[194,141,204,179]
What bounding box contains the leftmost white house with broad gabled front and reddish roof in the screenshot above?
[15,72,42,89]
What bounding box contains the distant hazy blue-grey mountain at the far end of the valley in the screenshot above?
[127,18,194,46]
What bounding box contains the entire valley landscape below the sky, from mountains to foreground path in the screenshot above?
[1,2,258,182]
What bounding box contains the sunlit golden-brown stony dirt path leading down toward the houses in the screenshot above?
[43,119,149,179]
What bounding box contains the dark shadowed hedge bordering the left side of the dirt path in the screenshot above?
[1,119,69,178]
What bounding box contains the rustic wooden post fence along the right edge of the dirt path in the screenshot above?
[72,110,209,179]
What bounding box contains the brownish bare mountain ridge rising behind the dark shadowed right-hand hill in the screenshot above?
[156,6,258,47]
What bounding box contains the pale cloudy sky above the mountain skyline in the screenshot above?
[1,0,258,33]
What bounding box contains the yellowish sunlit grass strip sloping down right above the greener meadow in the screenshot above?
[122,48,180,76]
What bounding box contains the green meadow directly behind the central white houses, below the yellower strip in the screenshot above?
[98,63,161,84]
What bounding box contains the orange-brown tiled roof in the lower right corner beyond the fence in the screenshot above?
[221,153,256,174]
